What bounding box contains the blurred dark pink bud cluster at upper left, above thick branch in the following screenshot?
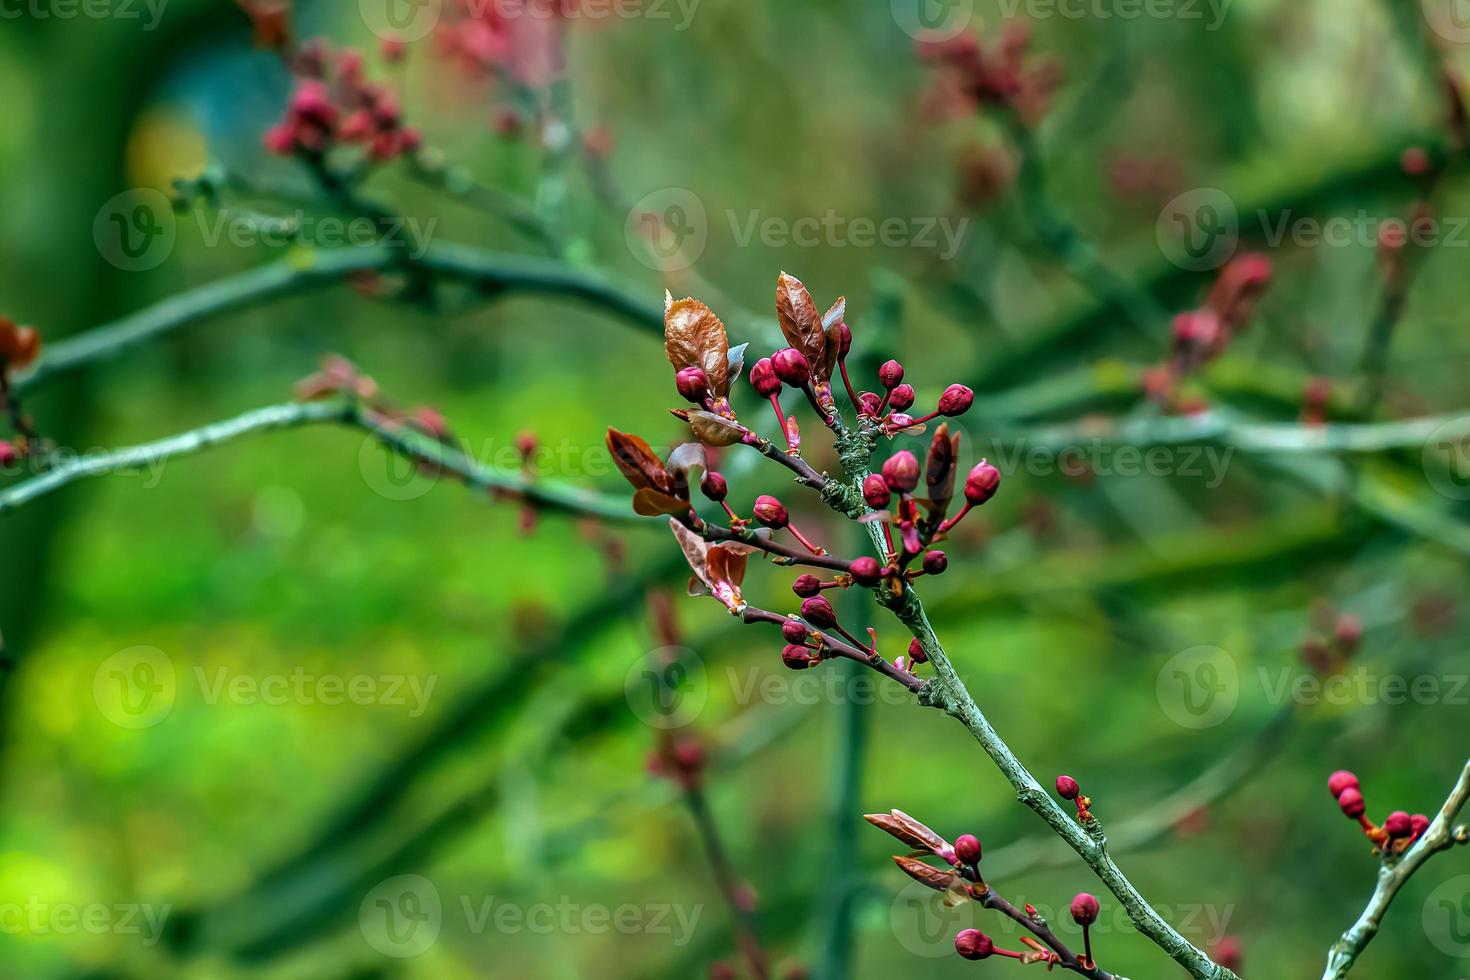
[265,40,423,163]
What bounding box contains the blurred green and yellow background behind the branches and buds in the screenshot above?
[0,0,1470,980]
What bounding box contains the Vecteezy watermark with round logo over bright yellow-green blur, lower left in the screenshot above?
[93,646,438,729]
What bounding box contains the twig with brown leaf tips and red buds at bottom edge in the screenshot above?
[863,810,1113,980]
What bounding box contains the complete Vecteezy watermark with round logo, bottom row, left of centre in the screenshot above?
[357,874,704,959]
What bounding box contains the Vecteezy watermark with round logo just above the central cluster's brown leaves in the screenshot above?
[623,187,972,272]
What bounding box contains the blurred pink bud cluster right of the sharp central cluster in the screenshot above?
[1144,253,1272,411]
